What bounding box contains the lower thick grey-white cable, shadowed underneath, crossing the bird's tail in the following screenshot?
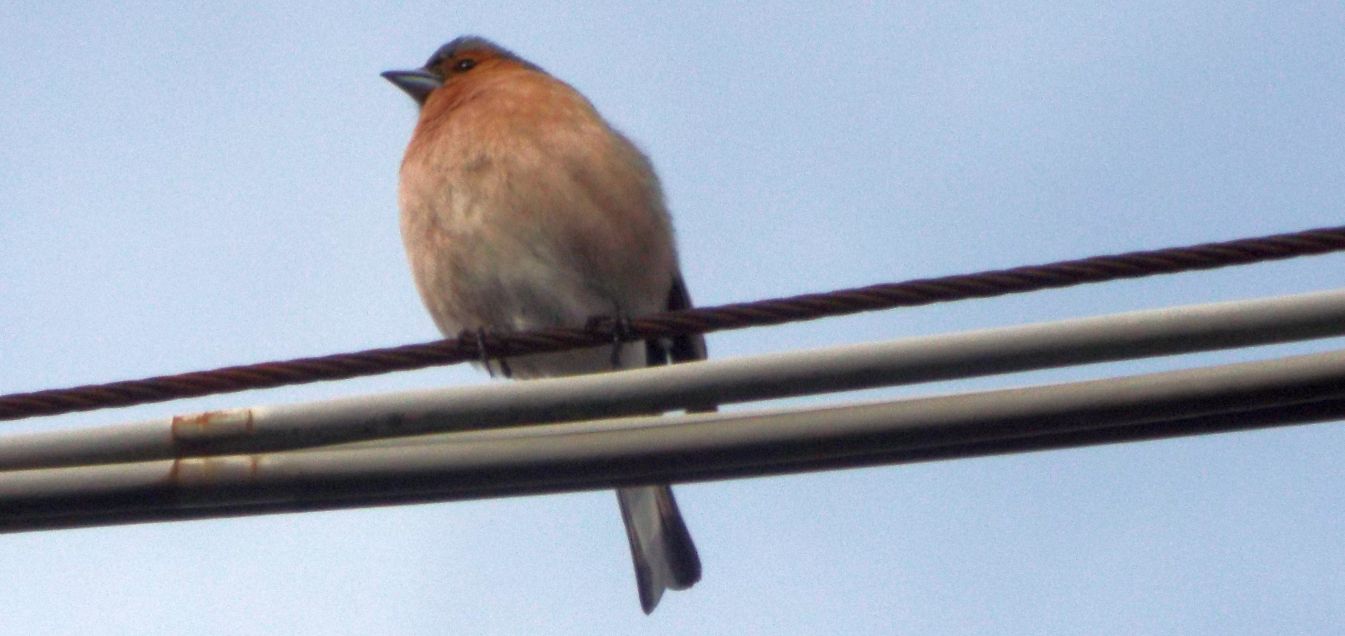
[0,351,1345,531]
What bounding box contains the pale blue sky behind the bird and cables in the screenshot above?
[0,1,1345,635]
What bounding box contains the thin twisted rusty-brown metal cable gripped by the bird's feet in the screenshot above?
[0,226,1345,421]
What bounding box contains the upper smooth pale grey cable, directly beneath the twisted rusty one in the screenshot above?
[0,290,1345,471]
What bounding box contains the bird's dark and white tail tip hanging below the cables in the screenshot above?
[616,485,701,613]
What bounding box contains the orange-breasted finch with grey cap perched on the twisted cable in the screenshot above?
[383,36,705,613]
